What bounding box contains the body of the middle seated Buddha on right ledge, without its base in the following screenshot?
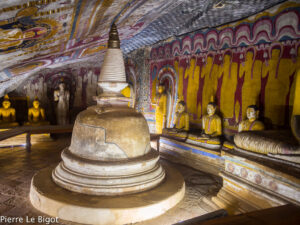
[202,102,222,138]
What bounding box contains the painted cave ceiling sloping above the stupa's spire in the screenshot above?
[0,0,284,96]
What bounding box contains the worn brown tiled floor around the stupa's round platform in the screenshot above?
[0,137,221,225]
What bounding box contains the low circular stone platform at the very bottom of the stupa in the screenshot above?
[30,165,185,225]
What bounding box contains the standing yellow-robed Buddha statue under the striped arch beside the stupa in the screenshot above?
[155,85,167,134]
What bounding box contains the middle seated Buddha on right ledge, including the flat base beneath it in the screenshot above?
[186,102,222,149]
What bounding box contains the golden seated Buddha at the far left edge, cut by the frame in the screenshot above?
[0,95,19,127]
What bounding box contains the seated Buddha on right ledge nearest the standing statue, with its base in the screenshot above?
[163,101,189,138]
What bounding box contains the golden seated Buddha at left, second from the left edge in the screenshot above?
[25,98,50,126]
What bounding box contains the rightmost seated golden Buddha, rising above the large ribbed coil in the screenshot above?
[238,105,265,132]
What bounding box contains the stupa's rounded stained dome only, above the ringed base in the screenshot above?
[69,107,151,161]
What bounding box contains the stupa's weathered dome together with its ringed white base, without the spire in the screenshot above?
[52,106,165,195]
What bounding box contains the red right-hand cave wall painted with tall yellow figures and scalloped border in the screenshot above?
[128,3,300,132]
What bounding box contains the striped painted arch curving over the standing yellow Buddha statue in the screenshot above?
[156,65,178,127]
